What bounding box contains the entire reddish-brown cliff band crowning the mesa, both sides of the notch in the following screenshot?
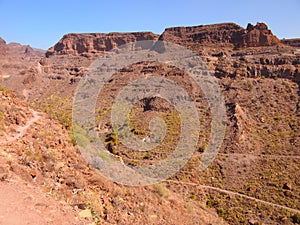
[46,23,281,57]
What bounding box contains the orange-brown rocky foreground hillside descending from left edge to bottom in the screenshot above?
[0,90,226,225]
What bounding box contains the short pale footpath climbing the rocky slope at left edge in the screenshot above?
[1,109,41,145]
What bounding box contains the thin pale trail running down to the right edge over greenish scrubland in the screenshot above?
[165,180,300,213]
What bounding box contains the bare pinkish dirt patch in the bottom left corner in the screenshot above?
[0,180,84,225]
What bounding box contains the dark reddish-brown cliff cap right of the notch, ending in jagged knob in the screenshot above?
[159,23,280,48]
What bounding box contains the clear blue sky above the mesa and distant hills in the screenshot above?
[0,0,300,49]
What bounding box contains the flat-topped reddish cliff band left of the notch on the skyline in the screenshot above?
[46,32,159,56]
